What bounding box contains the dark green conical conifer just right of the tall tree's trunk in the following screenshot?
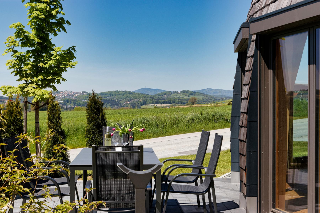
[45,95,70,162]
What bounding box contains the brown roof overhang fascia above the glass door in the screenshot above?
[250,0,320,34]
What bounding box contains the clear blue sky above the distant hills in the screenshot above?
[0,0,251,92]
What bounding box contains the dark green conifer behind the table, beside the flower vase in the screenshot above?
[85,92,107,147]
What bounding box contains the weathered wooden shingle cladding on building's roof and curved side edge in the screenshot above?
[238,0,304,197]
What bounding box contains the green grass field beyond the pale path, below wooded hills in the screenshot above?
[28,105,231,152]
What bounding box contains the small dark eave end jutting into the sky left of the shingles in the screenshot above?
[233,22,249,52]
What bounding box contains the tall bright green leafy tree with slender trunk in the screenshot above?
[0,0,77,156]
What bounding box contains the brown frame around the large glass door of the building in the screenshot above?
[257,24,320,212]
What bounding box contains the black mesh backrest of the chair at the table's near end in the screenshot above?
[92,146,143,209]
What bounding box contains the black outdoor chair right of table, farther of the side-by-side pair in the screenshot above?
[153,130,210,206]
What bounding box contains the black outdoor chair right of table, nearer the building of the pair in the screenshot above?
[161,133,223,213]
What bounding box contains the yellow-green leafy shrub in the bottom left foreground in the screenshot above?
[0,135,103,213]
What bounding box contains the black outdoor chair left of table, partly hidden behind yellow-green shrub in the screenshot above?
[4,138,79,206]
